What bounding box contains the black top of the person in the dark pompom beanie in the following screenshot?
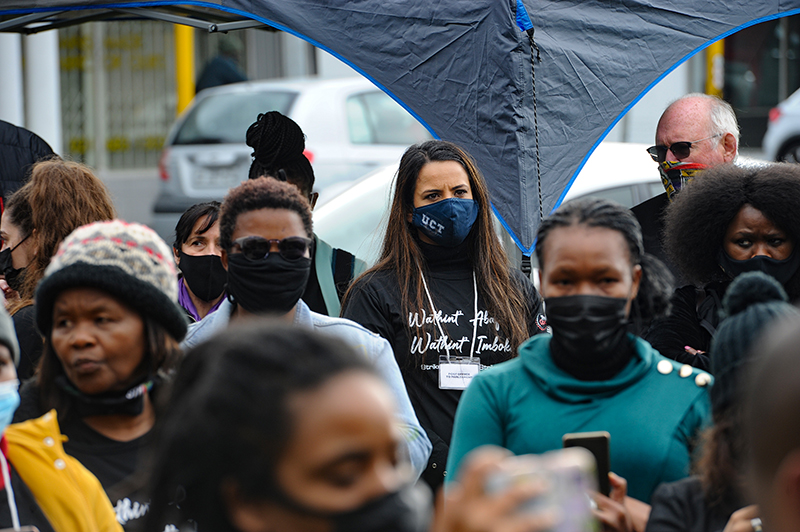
[645,477,744,532]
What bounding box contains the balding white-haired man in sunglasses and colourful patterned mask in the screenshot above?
[631,93,739,277]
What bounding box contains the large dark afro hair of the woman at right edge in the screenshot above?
[664,163,800,299]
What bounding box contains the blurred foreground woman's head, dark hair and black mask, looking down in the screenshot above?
[148,321,428,532]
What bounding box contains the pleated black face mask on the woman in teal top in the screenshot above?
[545,295,628,358]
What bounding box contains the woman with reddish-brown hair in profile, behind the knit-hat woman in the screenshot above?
[0,158,116,380]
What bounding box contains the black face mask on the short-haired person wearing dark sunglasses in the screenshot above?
[228,253,311,314]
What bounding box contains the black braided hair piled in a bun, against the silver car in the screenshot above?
[246,111,314,196]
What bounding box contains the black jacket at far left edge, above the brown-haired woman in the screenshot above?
[0,120,53,206]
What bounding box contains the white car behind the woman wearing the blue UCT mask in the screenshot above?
[314,142,664,265]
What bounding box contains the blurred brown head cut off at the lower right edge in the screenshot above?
[745,317,800,532]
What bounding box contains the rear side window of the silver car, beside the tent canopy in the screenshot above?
[347,91,431,146]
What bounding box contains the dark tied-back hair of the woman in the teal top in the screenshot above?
[536,198,674,324]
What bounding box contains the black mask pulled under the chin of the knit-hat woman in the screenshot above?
[55,375,156,418]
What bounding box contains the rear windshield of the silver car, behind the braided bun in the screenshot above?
[173,91,297,144]
